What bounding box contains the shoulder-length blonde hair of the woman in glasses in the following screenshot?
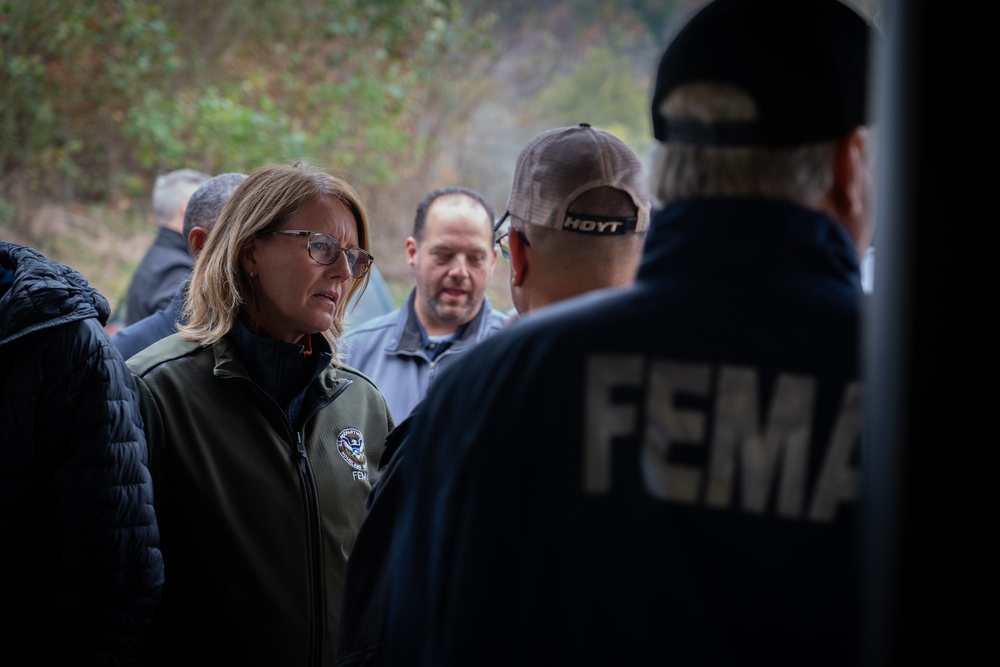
[178,162,371,359]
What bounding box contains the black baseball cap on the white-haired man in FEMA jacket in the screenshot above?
[652,0,875,148]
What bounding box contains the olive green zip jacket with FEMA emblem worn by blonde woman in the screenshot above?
[128,334,393,666]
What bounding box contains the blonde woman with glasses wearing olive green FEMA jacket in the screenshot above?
[129,163,394,665]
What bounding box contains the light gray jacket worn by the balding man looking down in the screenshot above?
[342,290,507,422]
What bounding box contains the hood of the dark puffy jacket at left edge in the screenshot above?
[0,241,111,345]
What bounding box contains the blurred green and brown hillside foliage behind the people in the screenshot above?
[0,0,876,314]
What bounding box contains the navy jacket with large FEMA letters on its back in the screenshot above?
[375,199,862,667]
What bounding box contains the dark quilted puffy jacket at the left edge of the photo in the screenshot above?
[0,241,163,665]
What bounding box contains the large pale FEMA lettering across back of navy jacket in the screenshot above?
[583,355,861,522]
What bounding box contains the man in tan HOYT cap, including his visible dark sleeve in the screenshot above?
[338,123,649,666]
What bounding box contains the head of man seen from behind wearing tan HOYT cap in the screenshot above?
[494,123,649,324]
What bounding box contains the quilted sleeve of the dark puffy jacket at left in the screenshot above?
[39,319,163,664]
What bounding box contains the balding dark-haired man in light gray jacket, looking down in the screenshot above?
[344,187,507,422]
